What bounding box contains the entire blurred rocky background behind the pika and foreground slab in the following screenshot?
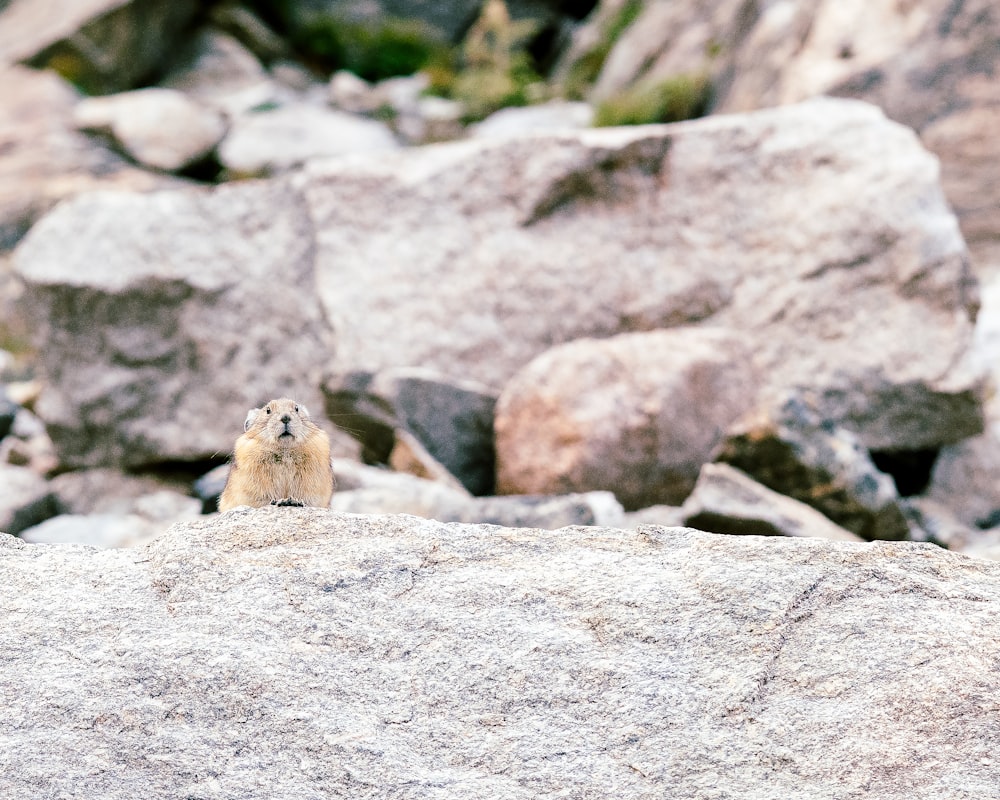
[0,0,1000,556]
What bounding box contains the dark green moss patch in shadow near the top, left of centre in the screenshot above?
[293,15,449,81]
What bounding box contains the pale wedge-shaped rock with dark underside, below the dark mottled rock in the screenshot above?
[682,464,861,542]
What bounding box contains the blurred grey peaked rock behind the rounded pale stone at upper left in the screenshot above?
[161,28,280,116]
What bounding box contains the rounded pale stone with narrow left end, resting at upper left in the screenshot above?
[74,88,226,172]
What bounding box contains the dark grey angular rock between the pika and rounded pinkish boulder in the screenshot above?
[323,367,496,495]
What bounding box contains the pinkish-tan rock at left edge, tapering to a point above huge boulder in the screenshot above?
[0,67,178,251]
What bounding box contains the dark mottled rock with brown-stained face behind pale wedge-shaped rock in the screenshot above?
[716,396,908,539]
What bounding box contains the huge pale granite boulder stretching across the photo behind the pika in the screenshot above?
[15,100,982,476]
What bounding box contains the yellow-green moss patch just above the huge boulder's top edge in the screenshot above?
[594,73,712,127]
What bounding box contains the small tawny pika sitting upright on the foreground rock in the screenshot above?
[219,397,333,511]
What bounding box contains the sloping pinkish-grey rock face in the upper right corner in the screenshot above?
[580,0,1000,276]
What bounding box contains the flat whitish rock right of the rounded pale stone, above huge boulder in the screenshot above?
[219,104,399,177]
